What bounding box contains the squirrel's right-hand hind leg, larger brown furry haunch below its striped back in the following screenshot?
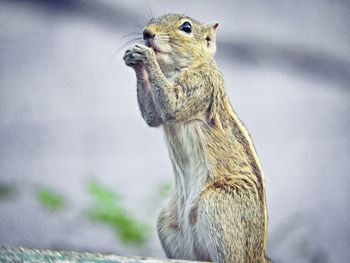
[194,187,265,263]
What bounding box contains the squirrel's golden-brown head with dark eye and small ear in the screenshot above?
[143,14,219,69]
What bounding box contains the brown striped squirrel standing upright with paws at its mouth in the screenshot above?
[123,14,270,263]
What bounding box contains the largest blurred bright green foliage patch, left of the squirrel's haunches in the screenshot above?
[87,181,149,246]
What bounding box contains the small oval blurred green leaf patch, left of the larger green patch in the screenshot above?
[36,187,65,212]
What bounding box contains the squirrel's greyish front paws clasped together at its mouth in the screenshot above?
[123,44,154,67]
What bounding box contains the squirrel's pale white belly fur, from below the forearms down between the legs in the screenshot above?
[164,121,209,259]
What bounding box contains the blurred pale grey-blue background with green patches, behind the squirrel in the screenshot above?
[0,0,350,262]
